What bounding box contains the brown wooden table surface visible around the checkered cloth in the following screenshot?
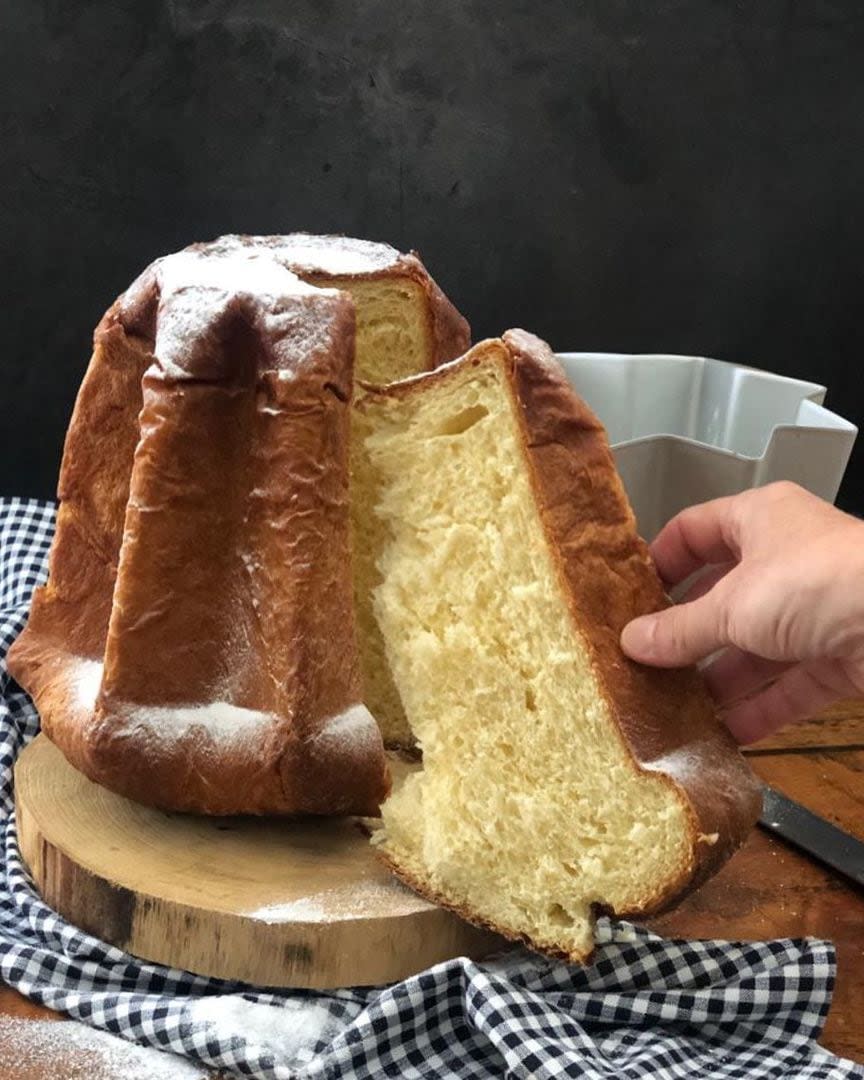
[0,701,864,1080]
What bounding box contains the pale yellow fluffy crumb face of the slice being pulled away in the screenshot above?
[365,342,692,959]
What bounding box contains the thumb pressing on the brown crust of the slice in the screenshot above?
[621,593,729,667]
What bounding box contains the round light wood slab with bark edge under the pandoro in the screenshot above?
[15,735,503,988]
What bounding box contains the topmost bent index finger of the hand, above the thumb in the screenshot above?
[651,497,740,585]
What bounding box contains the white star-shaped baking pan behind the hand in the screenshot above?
[558,352,858,540]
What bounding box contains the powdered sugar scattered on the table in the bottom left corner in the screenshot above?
[0,1018,203,1080]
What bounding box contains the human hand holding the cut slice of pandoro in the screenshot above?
[621,483,864,743]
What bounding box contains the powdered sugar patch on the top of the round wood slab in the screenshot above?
[244,878,433,923]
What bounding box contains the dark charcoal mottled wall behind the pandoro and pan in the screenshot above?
[0,0,864,511]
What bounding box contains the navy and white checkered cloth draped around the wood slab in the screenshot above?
[0,499,864,1080]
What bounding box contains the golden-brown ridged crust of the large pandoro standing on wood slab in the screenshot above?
[9,257,389,814]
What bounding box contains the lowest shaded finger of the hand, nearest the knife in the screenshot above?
[724,662,854,743]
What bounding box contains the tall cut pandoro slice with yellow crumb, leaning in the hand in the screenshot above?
[360,330,759,961]
